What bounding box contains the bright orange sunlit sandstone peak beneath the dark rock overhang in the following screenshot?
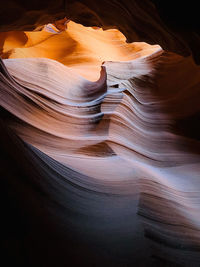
[0,19,161,81]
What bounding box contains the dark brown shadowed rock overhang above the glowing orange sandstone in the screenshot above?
[0,0,200,64]
